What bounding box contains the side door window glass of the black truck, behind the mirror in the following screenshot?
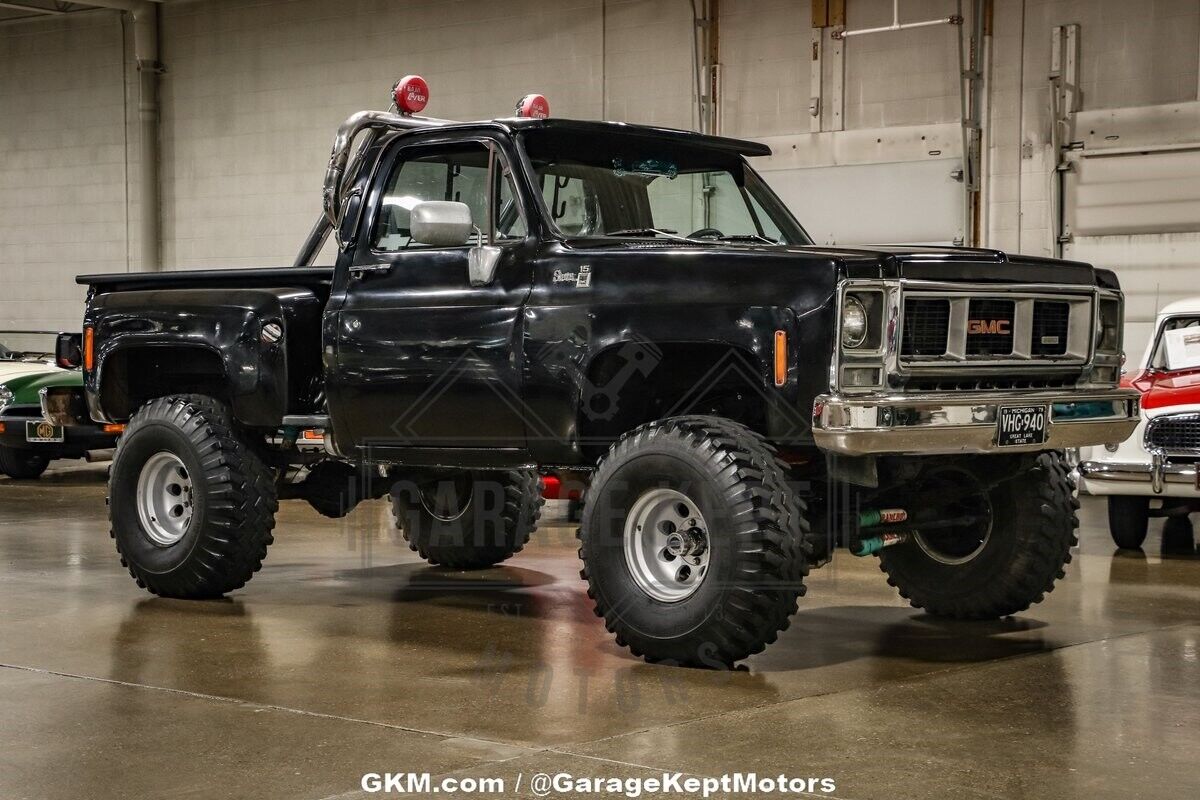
[372,142,526,252]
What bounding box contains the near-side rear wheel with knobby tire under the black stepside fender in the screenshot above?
[108,396,278,597]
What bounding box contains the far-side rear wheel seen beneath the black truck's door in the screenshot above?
[391,470,544,570]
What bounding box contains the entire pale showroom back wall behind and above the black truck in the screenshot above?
[0,0,1200,345]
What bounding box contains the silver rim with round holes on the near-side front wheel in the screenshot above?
[624,488,712,603]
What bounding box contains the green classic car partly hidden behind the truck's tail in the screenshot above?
[0,344,120,480]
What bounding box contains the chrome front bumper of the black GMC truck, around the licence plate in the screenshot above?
[812,389,1139,456]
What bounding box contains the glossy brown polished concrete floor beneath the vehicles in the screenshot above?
[0,468,1200,800]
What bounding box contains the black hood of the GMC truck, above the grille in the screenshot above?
[568,236,1117,289]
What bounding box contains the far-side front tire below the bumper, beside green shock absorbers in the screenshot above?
[880,452,1079,619]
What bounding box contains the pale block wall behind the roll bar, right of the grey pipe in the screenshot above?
[162,0,609,270]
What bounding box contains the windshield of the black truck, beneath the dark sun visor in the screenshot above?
[521,128,811,245]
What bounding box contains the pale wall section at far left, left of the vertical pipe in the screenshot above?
[0,14,127,348]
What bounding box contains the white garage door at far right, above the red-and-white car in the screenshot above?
[1063,145,1200,359]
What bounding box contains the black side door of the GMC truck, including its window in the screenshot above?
[325,134,534,464]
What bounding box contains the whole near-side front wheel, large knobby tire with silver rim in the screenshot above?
[580,416,811,667]
